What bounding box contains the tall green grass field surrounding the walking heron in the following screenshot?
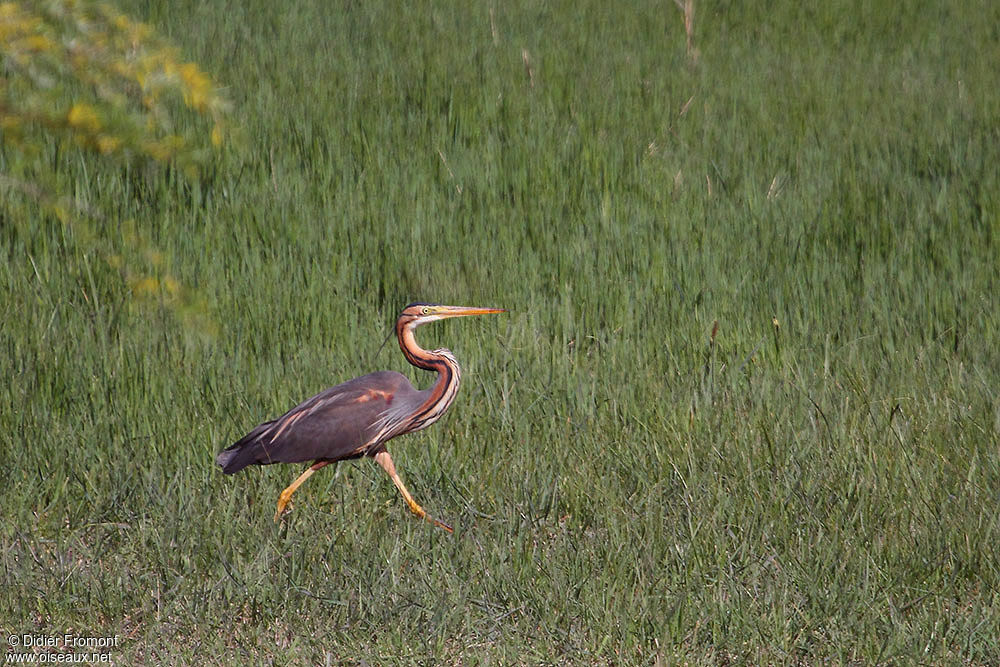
[0,0,1000,665]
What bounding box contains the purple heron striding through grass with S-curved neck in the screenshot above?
[215,303,506,533]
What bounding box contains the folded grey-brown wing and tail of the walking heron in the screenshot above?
[216,371,419,474]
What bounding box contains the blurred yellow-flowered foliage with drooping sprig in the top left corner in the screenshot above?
[0,0,229,332]
